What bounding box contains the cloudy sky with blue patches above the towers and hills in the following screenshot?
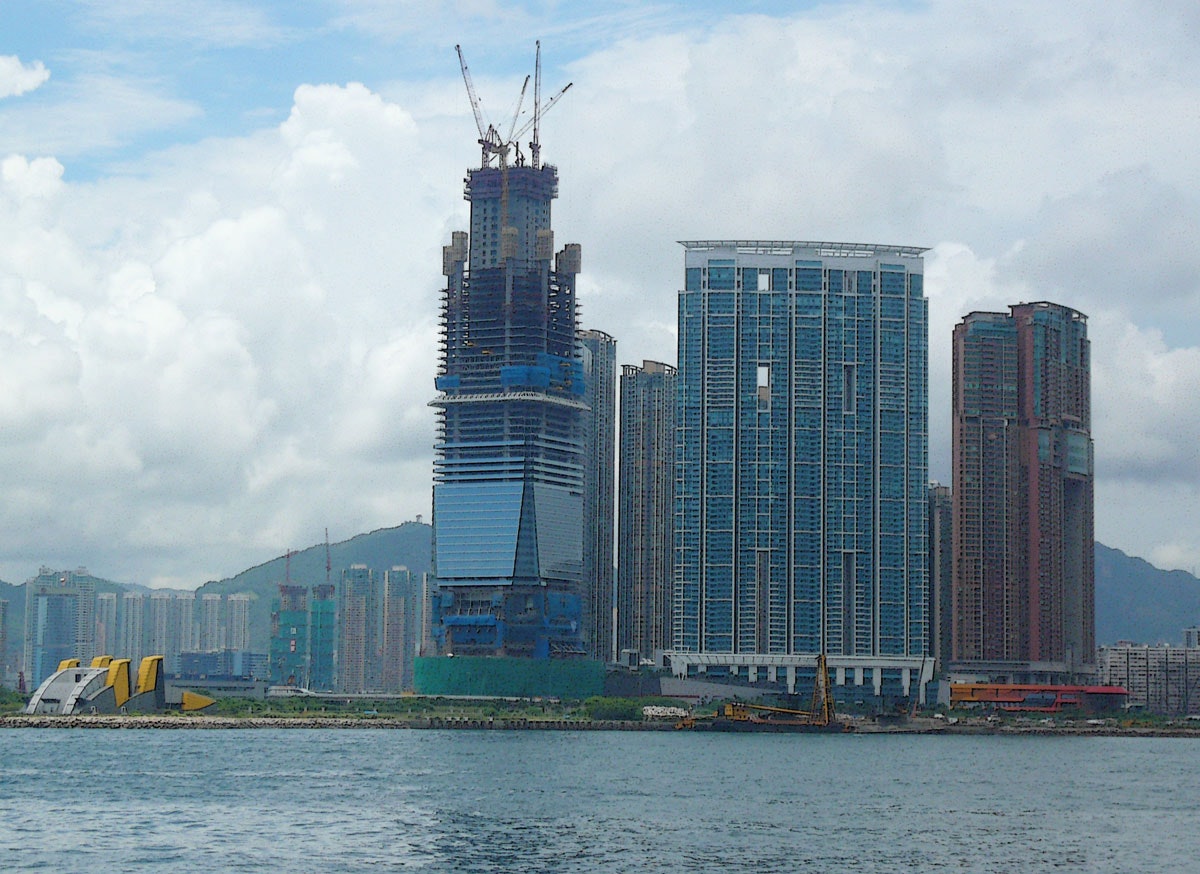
[0,0,1200,588]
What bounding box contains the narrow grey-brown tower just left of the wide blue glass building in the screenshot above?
[617,361,677,657]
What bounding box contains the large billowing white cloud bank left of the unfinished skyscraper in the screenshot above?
[0,85,451,585]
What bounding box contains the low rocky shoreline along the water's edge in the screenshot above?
[0,714,1200,737]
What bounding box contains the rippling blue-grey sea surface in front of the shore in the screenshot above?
[0,729,1200,874]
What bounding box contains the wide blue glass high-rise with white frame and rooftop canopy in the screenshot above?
[670,241,932,698]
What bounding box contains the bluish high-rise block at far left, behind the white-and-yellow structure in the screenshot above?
[25,568,96,688]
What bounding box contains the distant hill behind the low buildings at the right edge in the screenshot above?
[1096,543,1200,646]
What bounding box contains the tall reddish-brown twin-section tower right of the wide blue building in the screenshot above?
[953,301,1096,682]
